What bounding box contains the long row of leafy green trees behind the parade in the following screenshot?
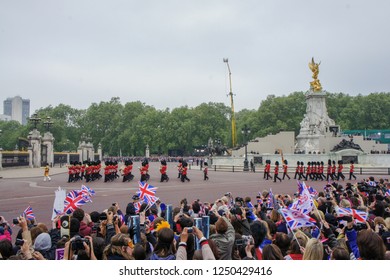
[0,92,390,156]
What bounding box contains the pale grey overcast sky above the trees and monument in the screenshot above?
[0,0,390,113]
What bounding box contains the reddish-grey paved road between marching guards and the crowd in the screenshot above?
[0,163,378,238]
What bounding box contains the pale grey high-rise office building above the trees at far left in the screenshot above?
[4,96,30,125]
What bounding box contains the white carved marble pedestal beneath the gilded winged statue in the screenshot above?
[296,90,335,154]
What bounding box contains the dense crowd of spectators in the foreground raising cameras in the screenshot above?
[0,177,390,260]
